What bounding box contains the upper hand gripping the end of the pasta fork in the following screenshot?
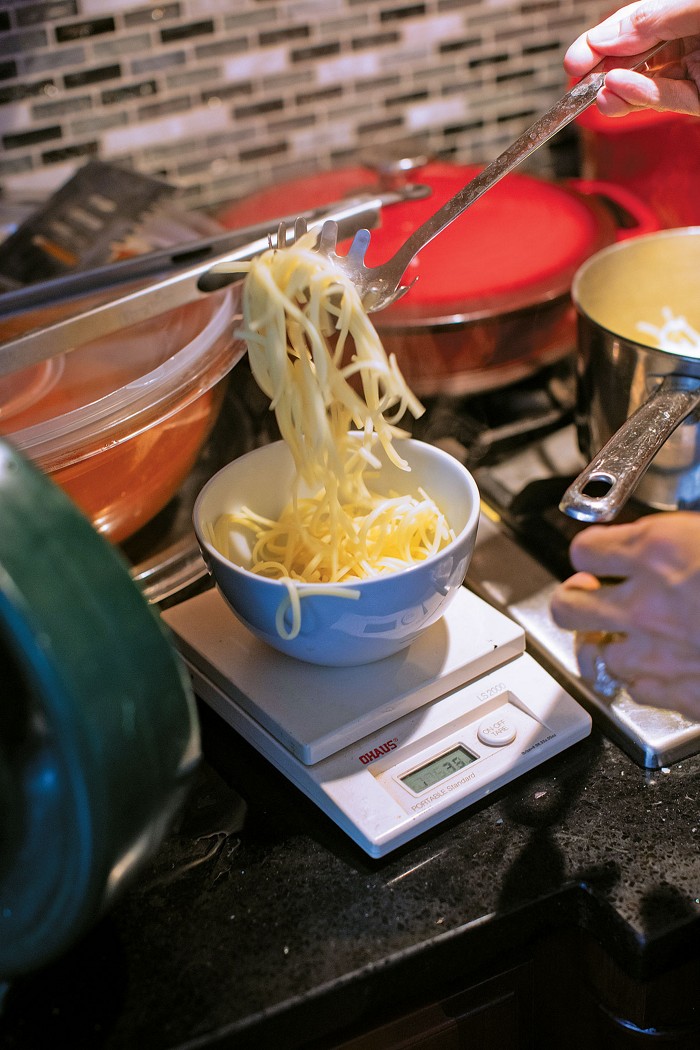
[564,0,700,117]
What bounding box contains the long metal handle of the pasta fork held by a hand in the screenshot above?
[384,41,666,274]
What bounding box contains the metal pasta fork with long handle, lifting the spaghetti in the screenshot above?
[302,41,665,313]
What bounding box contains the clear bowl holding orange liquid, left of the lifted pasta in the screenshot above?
[0,297,242,543]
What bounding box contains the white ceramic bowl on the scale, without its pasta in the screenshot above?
[193,439,479,667]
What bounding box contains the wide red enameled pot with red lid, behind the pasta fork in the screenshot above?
[217,163,659,395]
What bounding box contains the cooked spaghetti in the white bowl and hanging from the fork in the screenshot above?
[207,233,453,584]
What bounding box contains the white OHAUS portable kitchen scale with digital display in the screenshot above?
[163,587,591,857]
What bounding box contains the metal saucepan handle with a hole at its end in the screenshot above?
[559,375,700,522]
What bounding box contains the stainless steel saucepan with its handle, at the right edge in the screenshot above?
[559,226,700,522]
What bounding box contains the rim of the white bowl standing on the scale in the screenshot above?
[192,438,481,597]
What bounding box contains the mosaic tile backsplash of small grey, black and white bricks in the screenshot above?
[0,0,611,210]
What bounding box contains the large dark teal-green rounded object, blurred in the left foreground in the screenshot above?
[0,438,200,980]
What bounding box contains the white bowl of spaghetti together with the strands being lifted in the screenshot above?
[194,221,479,666]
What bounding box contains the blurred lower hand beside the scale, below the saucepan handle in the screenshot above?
[551,511,700,721]
